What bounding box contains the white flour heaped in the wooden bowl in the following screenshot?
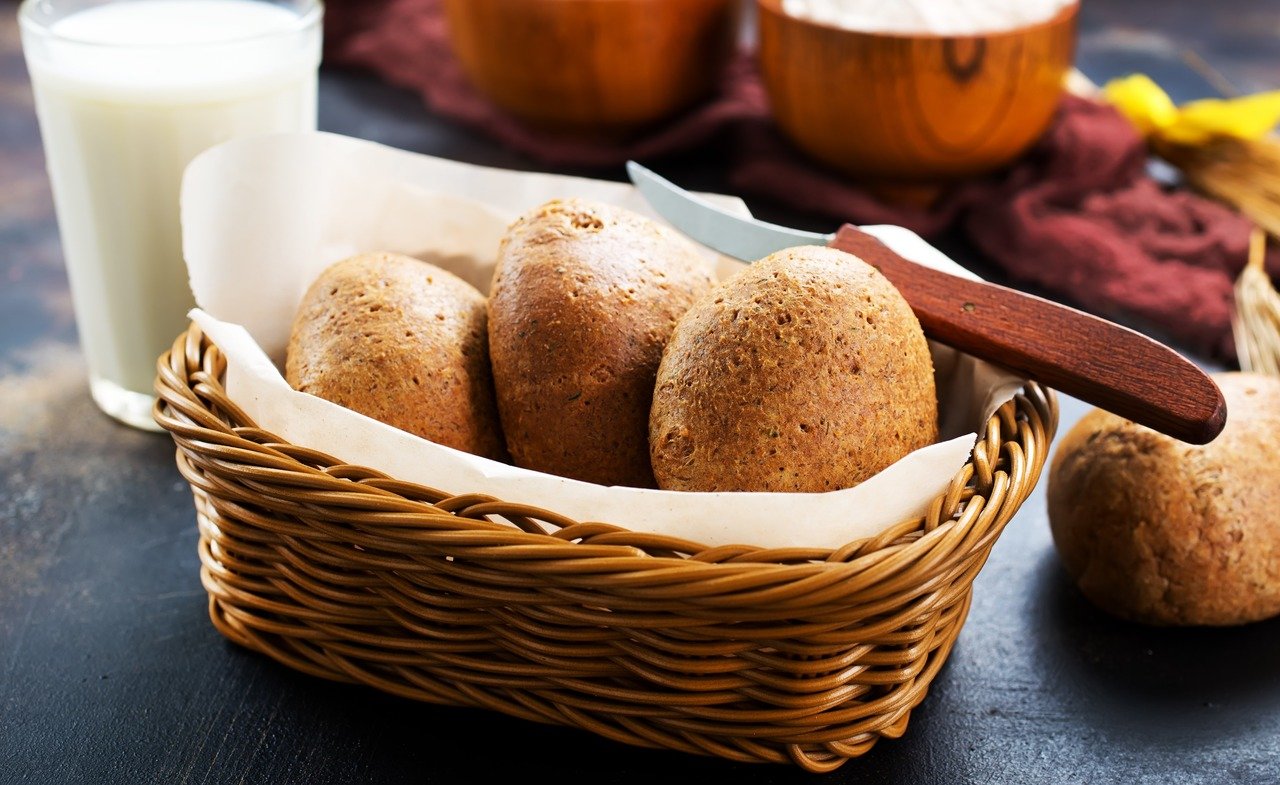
[782,0,1078,36]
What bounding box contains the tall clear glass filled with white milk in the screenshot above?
[18,0,323,430]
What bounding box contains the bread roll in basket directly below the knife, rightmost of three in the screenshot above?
[649,247,938,492]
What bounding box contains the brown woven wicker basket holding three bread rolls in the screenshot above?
[155,325,1057,771]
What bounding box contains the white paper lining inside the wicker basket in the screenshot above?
[182,133,1024,548]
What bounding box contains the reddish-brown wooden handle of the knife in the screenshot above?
[831,224,1226,444]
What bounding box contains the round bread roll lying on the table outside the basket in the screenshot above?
[1048,374,1280,625]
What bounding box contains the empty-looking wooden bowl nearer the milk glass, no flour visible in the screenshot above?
[444,0,740,136]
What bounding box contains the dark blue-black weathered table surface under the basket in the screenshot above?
[0,0,1280,784]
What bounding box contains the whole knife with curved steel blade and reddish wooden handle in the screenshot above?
[627,161,1226,444]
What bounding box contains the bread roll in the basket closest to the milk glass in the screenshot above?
[284,254,506,460]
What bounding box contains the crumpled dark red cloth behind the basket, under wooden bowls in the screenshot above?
[325,0,1280,357]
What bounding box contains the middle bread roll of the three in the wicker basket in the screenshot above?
[489,200,713,488]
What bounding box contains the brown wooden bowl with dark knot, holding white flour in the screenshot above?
[758,0,1079,188]
